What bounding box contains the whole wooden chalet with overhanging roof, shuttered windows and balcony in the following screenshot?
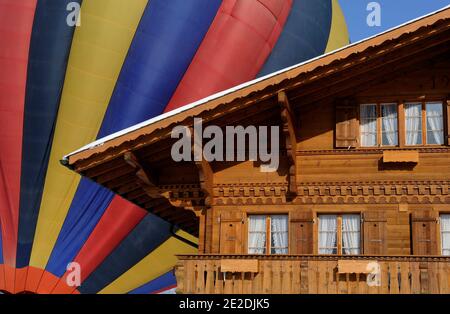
[63,8,450,294]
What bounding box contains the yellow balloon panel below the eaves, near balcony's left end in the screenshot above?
[99,231,198,294]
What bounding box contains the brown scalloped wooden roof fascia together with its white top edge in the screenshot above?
[63,5,450,165]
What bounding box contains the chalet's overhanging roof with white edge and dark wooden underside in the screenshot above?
[62,6,450,235]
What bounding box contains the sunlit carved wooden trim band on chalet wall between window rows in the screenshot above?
[213,181,450,205]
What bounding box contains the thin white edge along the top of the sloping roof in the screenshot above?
[63,5,450,161]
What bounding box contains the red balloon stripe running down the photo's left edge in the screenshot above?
[0,0,36,267]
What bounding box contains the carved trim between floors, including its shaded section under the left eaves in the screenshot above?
[140,181,450,210]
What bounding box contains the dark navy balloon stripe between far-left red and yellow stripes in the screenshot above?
[16,0,80,268]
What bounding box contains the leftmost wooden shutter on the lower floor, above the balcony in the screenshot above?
[219,211,244,254]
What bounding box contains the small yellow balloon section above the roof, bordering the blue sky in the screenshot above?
[325,0,349,53]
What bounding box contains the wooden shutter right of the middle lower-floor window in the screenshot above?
[363,211,387,255]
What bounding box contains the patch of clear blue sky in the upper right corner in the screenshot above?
[339,0,450,42]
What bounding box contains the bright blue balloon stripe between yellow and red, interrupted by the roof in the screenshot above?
[46,0,220,276]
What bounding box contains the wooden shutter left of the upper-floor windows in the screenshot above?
[335,102,358,148]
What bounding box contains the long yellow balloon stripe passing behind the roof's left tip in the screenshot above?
[30,0,147,268]
